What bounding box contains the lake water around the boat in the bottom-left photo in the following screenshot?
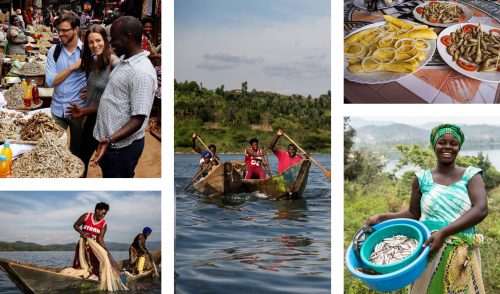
[0,251,161,294]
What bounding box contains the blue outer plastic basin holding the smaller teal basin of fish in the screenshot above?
[345,218,431,292]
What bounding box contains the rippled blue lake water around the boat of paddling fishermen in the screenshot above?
[174,155,331,294]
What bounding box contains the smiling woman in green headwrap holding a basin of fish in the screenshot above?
[365,124,488,294]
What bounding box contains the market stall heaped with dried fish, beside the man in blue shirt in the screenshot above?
[0,25,84,178]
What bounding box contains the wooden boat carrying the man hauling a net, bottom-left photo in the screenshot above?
[0,249,161,294]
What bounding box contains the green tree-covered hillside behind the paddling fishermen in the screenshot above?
[174,81,331,153]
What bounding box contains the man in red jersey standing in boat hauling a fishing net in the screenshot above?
[73,202,109,277]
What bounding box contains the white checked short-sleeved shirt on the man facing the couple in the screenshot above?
[93,52,157,148]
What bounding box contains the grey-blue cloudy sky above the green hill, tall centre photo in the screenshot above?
[174,0,330,97]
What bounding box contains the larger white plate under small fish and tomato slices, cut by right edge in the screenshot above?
[437,23,500,84]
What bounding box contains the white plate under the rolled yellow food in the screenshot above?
[344,21,436,84]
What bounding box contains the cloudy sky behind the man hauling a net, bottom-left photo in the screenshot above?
[0,191,161,245]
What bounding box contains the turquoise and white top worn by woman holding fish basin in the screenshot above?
[416,167,482,235]
